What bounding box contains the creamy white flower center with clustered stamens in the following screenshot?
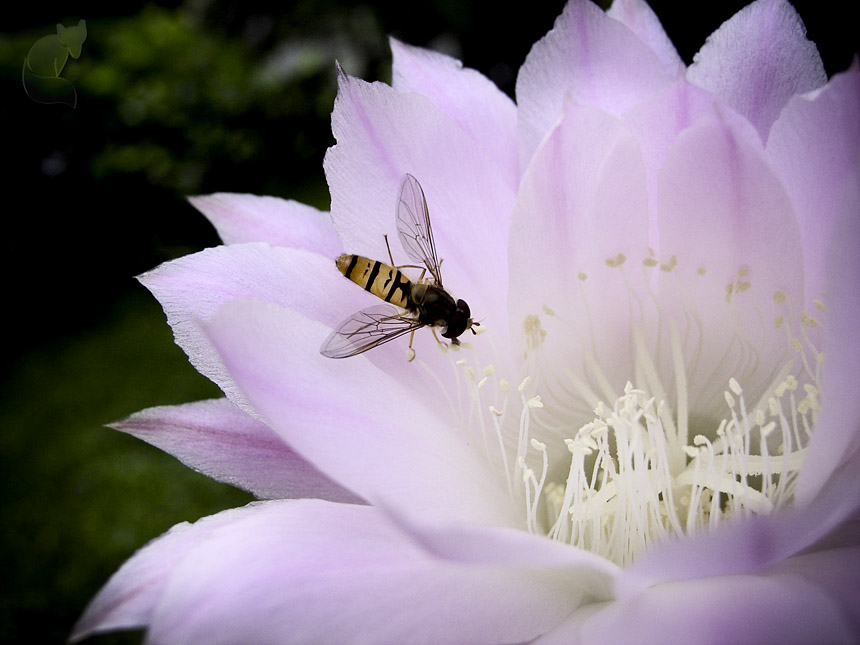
[440,250,823,565]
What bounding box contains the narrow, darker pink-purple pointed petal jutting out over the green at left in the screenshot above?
[111,399,361,503]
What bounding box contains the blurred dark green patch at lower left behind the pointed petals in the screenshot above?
[0,294,251,643]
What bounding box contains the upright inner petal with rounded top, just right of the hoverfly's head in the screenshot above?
[508,103,648,423]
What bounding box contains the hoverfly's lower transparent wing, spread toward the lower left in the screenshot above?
[320,305,424,358]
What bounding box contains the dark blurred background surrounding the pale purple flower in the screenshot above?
[0,0,857,643]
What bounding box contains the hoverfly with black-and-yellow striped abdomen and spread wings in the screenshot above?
[320,174,478,360]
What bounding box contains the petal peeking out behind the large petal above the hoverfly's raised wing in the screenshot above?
[389,38,520,190]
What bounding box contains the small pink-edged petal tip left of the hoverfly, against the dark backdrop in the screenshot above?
[188,193,343,258]
